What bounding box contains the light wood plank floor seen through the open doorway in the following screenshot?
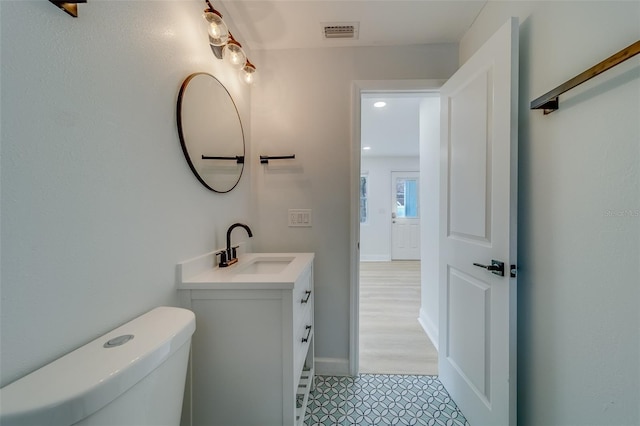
[359,261,438,375]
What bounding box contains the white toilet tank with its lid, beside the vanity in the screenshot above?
[0,307,195,426]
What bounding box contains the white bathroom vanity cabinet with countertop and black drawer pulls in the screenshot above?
[178,252,314,426]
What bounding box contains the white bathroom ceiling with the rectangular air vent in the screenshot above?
[219,0,487,50]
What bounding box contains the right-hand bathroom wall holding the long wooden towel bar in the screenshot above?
[460,1,640,425]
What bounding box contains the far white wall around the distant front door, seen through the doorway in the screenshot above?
[360,156,420,262]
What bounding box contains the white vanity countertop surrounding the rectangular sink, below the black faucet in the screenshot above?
[178,252,314,290]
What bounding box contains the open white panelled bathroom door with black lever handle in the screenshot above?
[438,18,518,426]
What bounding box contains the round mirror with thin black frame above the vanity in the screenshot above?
[177,72,244,192]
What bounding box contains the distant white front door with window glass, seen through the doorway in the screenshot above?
[391,172,420,260]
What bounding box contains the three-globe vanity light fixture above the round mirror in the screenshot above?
[202,0,257,85]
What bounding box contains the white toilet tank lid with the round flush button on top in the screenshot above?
[0,307,195,425]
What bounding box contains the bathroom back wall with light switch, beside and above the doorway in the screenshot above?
[251,45,457,373]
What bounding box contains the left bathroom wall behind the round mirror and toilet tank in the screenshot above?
[0,1,259,385]
